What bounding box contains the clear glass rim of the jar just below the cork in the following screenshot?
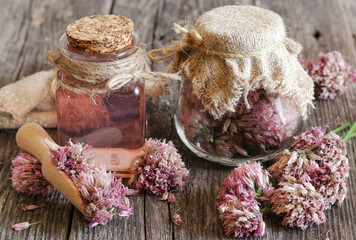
[59,31,141,62]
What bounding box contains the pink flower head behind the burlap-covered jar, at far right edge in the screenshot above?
[300,51,356,99]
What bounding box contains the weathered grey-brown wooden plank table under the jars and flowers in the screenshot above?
[0,0,356,240]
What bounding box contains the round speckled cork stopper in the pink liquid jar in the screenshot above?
[66,15,134,53]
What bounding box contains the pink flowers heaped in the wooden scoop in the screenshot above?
[49,141,132,227]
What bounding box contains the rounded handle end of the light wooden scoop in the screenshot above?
[16,123,59,164]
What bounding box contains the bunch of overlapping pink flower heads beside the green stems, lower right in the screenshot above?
[268,126,350,229]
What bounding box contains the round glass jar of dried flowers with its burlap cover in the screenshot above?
[149,5,314,166]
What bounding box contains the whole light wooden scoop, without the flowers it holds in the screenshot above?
[16,123,84,214]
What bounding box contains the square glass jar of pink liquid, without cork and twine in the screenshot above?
[56,32,146,149]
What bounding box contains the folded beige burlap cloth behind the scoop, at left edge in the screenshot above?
[0,69,57,128]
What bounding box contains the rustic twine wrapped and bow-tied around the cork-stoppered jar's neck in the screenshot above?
[48,45,181,96]
